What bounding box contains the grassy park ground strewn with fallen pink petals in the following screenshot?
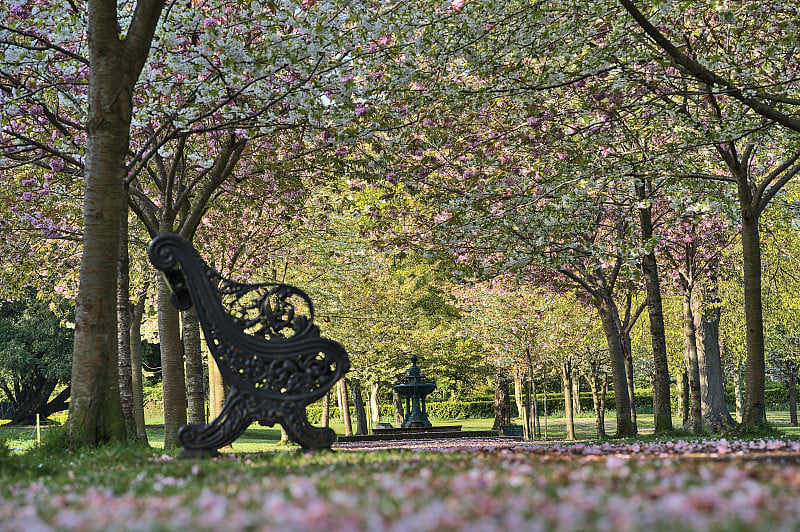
[0,412,800,532]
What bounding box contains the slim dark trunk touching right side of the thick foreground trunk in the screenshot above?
[117,208,136,440]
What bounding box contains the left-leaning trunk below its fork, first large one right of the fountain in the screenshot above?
[594,297,636,437]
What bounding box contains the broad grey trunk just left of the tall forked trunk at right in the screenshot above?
[692,279,736,432]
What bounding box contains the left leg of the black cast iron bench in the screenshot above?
[178,386,255,458]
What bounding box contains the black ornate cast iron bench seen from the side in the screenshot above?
[148,233,350,457]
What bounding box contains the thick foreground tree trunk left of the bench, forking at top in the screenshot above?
[66,0,164,447]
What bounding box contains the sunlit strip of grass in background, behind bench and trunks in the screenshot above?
[6,411,800,453]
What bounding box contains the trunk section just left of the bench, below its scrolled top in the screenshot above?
[158,277,187,449]
